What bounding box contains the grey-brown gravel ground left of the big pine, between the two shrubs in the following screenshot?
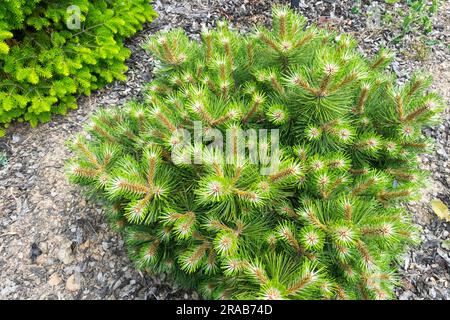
[0,0,278,299]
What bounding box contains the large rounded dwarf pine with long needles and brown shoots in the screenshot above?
[67,7,443,299]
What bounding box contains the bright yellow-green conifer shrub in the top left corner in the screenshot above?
[0,0,156,135]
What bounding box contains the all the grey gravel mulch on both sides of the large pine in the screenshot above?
[0,0,450,299]
